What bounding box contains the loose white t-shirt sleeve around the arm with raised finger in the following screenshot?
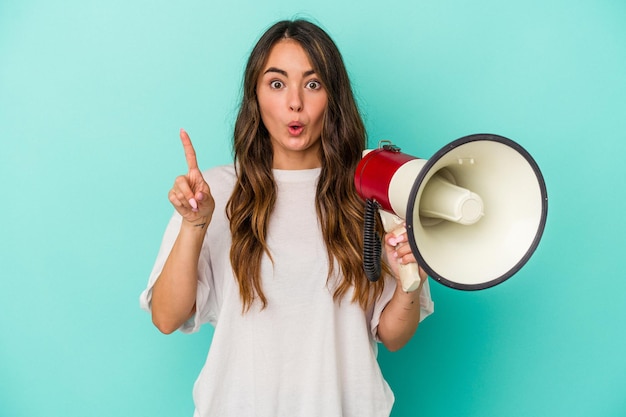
[139,212,215,333]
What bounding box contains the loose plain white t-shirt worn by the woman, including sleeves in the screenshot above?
[140,166,433,417]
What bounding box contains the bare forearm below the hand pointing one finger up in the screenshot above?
[152,220,208,333]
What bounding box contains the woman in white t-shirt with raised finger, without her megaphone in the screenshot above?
[141,20,432,417]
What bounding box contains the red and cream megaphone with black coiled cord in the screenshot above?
[354,134,548,291]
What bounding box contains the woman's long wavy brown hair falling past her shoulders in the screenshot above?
[226,20,384,312]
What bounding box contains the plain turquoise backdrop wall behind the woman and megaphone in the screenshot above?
[0,0,626,417]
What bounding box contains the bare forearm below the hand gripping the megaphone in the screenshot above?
[378,283,422,351]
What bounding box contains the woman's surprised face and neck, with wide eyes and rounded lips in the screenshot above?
[256,39,328,169]
